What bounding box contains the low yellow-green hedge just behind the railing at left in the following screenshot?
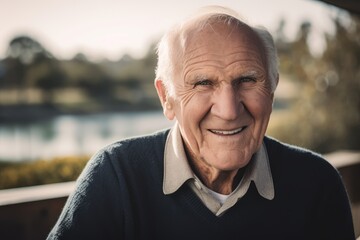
[0,156,89,189]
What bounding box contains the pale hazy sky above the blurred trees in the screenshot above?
[0,0,344,60]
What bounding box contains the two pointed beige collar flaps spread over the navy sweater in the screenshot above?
[163,122,275,200]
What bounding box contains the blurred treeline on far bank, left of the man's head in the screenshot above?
[0,36,160,113]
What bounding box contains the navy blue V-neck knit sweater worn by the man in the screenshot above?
[48,131,355,240]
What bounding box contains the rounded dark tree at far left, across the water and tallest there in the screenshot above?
[4,36,64,104]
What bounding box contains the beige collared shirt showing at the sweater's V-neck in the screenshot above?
[163,123,275,216]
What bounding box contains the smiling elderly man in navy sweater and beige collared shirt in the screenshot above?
[49,5,355,240]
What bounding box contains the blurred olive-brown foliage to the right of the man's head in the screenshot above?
[271,13,360,152]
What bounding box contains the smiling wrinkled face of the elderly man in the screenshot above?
[160,24,273,171]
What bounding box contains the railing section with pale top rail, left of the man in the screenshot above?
[0,182,75,240]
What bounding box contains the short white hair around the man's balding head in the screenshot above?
[155,6,279,96]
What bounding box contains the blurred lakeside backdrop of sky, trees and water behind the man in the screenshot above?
[0,0,360,188]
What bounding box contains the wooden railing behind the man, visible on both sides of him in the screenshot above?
[0,152,360,240]
